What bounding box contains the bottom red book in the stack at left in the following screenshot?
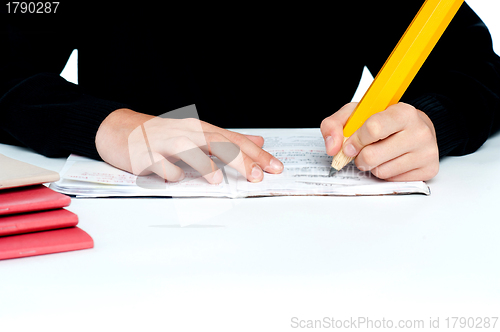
[0,227,94,259]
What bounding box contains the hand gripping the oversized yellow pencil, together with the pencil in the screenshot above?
[321,0,463,181]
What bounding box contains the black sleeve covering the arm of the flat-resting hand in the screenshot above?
[0,14,126,159]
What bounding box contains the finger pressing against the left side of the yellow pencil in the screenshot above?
[320,103,358,156]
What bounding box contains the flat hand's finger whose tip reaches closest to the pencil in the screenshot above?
[203,123,283,178]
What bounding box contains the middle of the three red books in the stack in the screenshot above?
[0,209,78,236]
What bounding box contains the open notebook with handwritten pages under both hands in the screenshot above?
[50,129,430,198]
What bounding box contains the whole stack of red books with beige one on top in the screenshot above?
[0,155,94,259]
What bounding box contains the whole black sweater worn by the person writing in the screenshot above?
[0,1,500,158]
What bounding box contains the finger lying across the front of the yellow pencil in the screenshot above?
[343,103,415,157]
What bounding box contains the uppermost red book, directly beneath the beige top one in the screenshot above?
[0,185,71,215]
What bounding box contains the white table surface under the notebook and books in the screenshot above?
[0,128,500,332]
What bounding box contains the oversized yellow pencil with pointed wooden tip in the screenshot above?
[330,0,463,176]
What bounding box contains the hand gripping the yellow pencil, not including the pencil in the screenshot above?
[321,103,439,181]
